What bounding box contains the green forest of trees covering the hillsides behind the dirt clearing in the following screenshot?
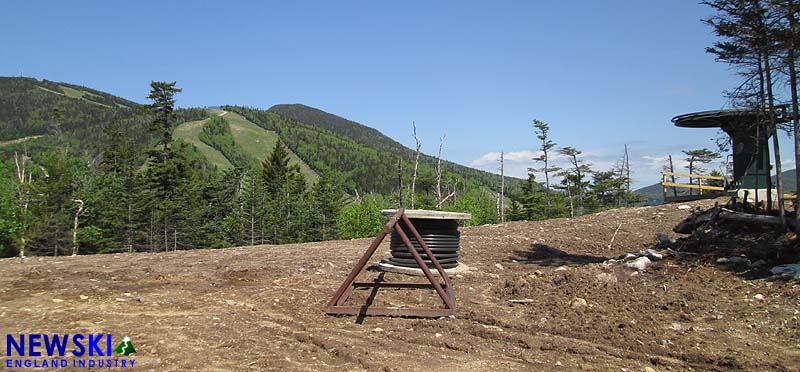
[0,78,640,256]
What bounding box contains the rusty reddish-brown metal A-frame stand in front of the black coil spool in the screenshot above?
[326,208,456,318]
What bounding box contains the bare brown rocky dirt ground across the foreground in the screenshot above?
[0,201,800,371]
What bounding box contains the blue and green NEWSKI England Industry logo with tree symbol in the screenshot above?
[5,333,136,368]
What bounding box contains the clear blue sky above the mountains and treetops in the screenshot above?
[0,0,789,186]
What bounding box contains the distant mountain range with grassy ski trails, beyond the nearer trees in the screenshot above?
[0,77,522,198]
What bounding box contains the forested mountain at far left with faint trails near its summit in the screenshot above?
[0,77,207,159]
